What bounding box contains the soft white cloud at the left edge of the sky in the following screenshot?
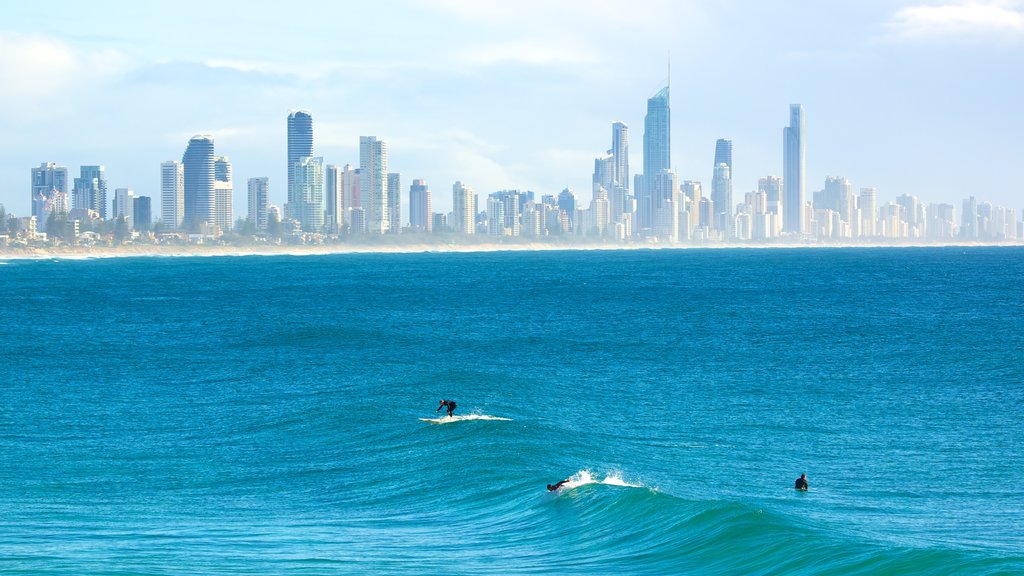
[0,32,131,121]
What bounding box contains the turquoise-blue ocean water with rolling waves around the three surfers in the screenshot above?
[0,248,1024,574]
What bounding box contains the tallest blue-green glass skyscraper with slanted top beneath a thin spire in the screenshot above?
[637,86,672,233]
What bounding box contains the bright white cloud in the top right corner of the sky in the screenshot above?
[889,0,1024,40]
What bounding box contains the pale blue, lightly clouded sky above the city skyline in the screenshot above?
[0,0,1024,221]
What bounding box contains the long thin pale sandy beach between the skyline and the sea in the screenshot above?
[0,242,1024,260]
